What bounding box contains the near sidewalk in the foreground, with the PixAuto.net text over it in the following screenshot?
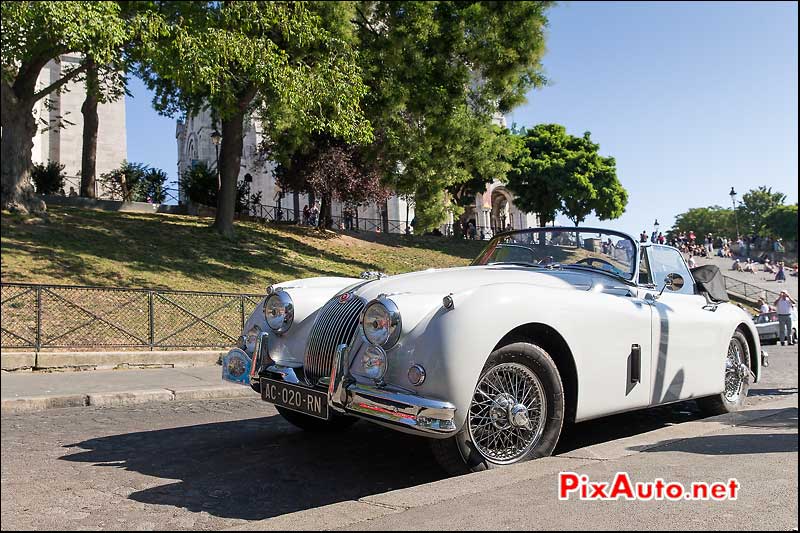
[232,396,798,531]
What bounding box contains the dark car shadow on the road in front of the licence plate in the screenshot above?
[61,416,446,520]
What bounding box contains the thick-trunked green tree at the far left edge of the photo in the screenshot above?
[0,2,130,213]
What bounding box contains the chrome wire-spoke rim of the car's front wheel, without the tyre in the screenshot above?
[468,363,547,464]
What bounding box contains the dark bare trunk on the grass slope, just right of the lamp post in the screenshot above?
[211,109,244,238]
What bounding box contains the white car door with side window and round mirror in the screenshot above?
[645,245,730,405]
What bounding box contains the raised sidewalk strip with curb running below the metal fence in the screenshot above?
[0,365,255,413]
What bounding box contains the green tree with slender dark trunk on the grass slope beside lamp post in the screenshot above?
[135,2,371,236]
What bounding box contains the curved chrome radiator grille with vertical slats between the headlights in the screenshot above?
[303,293,366,385]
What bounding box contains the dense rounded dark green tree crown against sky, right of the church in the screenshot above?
[508,124,628,225]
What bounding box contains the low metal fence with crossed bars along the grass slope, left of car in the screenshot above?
[0,283,263,351]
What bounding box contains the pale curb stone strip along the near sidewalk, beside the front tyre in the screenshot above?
[226,396,797,531]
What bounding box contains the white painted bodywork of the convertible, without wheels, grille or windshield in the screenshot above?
[239,233,760,427]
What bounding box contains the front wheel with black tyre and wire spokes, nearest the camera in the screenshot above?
[430,343,564,475]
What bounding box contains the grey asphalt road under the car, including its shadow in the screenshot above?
[0,346,797,530]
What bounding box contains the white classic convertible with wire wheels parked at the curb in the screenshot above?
[223,227,762,473]
